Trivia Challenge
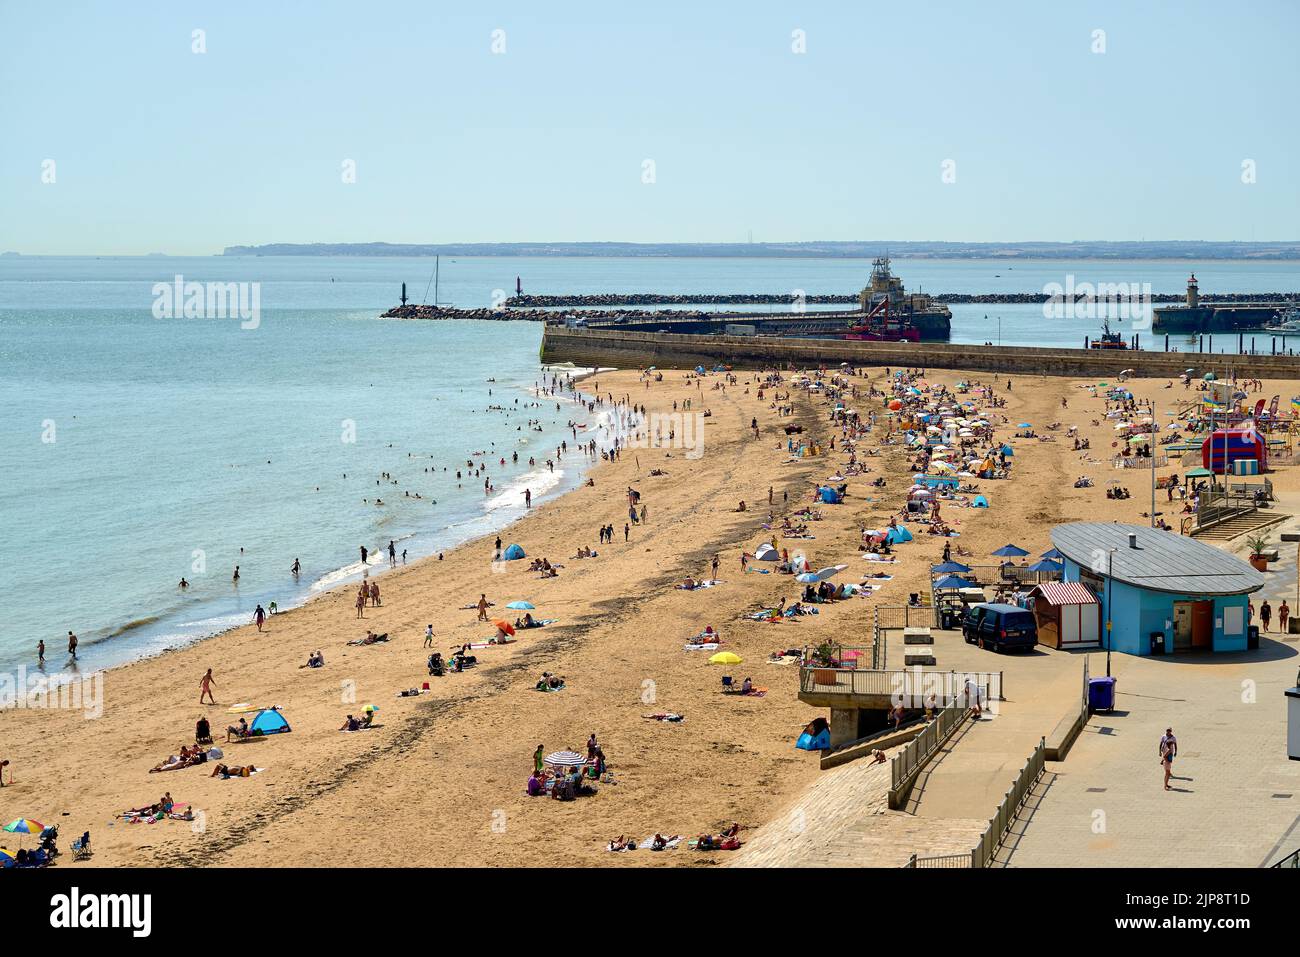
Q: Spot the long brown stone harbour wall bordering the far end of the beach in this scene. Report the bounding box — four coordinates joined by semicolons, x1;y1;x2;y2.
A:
542;326;1300;378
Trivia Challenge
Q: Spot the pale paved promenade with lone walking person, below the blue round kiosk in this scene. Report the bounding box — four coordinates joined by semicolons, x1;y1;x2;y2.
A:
1004;636;1300;867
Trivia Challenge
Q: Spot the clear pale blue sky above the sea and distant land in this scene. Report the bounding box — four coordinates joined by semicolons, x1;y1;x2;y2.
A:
0;0;1300;255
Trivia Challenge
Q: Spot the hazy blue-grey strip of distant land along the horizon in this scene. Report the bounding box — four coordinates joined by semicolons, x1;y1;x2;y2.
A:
221;239;1300;261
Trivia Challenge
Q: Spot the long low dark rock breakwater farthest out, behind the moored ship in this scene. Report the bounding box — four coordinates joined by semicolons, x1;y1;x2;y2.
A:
504;293;1294;309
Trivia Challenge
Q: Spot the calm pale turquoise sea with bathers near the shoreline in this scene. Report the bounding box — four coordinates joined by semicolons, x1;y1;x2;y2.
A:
0;256;1300;672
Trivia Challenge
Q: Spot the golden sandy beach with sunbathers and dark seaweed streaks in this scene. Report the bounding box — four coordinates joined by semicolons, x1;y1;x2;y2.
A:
0;369;1297;867
